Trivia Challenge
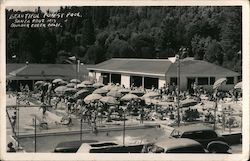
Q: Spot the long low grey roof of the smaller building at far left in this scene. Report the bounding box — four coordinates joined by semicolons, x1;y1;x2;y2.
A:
6;64;88;80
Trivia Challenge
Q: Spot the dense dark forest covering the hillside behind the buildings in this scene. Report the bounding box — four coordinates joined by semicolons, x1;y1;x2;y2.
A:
6;6;242;73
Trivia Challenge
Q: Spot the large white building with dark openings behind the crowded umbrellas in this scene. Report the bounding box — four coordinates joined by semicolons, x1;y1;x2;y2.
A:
87;58;240;90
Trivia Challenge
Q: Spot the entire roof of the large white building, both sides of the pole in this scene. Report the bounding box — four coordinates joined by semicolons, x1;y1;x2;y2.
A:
88;58;239;77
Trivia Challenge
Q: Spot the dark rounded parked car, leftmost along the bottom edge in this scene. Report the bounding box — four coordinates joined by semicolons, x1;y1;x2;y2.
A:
54;140;97;153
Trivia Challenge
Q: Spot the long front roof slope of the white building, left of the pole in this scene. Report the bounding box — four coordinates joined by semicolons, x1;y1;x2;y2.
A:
88;58;171;76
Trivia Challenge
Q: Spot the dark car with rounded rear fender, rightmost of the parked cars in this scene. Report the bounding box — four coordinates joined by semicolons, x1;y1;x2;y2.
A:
170;124;230;153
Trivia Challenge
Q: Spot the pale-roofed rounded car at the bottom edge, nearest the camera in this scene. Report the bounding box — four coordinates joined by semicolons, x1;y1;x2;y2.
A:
142;138;207;153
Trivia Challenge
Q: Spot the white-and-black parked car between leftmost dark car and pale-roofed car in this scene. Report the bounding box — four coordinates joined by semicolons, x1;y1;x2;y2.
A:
77;142;144;153
